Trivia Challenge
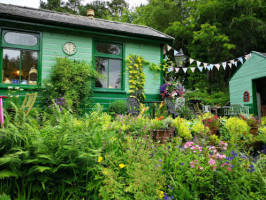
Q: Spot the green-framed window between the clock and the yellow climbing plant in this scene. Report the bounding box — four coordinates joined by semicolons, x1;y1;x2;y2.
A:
95;42;123;90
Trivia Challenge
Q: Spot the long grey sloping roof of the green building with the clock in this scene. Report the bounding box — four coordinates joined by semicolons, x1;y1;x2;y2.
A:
0;3;174;41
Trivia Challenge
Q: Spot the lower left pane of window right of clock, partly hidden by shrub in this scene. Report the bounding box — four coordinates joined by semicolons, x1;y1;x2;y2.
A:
95;57;108;88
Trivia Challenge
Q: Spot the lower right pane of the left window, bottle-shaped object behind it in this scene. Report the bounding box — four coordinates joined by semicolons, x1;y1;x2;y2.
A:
21;51;38;85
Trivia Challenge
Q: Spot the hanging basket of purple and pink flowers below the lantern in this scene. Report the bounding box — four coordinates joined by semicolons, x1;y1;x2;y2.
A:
160;81;184;99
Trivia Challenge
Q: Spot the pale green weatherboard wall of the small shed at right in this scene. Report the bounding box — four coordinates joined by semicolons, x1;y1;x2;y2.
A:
229;52;266;115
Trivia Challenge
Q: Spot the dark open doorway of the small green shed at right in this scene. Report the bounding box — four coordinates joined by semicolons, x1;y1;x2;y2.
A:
254;77;266;118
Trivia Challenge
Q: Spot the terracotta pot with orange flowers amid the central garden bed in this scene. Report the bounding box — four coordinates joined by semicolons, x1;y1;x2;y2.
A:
150;116;174;142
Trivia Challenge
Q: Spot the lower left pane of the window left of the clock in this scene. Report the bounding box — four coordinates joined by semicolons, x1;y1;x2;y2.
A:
2;49;20;84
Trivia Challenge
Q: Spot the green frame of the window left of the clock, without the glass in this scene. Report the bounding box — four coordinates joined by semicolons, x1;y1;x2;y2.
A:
0;27;42;89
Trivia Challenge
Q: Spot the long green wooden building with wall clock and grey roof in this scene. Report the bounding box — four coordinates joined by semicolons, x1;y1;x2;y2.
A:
0;4;174;111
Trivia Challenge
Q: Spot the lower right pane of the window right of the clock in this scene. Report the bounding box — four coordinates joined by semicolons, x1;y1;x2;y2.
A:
109;59;121;89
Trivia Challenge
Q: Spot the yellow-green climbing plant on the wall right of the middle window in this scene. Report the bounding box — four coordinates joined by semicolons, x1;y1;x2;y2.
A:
126;55;149;101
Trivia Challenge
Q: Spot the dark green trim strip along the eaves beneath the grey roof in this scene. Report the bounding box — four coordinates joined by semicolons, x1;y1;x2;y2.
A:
0;19;174;45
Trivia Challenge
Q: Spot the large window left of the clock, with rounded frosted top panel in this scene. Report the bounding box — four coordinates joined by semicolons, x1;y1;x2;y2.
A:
1;30;39;85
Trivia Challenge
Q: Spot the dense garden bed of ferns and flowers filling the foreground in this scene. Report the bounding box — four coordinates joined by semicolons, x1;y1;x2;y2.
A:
0;106;266;200
